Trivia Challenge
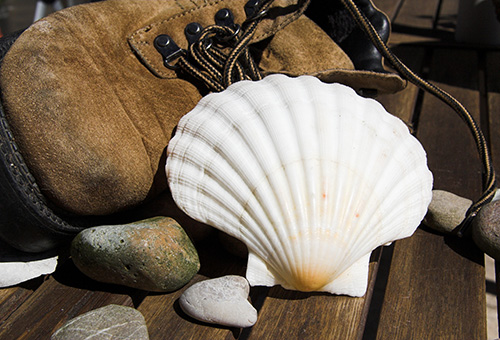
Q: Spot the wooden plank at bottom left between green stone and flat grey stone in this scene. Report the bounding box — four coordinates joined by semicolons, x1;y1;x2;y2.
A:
0;262;141;340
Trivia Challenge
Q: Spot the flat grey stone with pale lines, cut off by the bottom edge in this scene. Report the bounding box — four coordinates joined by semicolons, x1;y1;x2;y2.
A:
50;305;149;340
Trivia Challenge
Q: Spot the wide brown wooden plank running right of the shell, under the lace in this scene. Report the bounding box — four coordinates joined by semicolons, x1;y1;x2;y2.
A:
377;50;486;339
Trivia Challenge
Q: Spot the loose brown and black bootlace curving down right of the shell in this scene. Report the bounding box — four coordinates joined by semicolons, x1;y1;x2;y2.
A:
341;0;496;236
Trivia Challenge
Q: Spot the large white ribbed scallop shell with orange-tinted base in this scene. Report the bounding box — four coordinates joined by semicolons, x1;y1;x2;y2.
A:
166;75;432;296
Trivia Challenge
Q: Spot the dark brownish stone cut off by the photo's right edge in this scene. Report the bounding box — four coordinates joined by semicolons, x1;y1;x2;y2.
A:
471;201;500;261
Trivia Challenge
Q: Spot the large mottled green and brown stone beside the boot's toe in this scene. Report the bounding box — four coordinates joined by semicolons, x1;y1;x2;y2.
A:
71;217;200;292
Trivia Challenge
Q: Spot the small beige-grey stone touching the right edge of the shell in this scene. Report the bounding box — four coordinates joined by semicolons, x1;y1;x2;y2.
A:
424;190;472;234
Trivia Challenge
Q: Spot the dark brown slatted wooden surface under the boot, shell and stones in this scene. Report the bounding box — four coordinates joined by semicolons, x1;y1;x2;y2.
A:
0;0;500;340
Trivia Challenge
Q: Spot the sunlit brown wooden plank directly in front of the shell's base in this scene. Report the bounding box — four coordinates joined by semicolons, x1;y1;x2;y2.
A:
249;250;380;340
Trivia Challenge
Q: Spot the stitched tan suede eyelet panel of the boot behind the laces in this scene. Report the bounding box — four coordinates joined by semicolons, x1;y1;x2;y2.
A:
128;0;309;78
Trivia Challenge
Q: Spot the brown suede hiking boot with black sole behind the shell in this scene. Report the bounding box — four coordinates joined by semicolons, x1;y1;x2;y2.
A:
0;0;405;252
